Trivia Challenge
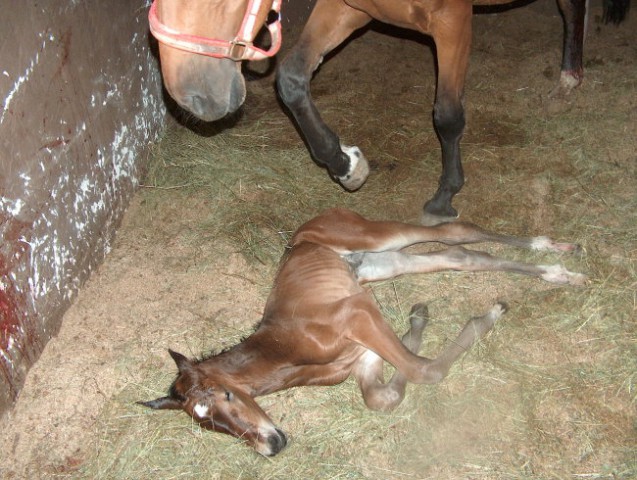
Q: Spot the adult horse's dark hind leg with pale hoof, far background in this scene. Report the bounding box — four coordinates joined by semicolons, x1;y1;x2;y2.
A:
549;0;588;97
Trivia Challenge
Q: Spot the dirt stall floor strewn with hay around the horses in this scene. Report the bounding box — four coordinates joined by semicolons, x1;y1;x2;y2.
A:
0;0;637;479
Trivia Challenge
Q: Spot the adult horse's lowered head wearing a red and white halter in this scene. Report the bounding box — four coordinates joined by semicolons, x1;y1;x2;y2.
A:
149;0;281;121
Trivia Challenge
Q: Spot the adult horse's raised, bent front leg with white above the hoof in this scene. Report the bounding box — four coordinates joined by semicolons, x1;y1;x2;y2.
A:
276;0;371;191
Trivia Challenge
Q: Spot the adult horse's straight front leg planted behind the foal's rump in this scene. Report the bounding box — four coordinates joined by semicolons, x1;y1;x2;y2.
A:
422;0;471;225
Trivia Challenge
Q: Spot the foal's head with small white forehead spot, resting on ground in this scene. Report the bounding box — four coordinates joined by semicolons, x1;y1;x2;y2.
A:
139;350;287;457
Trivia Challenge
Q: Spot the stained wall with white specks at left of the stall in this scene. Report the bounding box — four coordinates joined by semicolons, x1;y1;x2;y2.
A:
0;0;165;413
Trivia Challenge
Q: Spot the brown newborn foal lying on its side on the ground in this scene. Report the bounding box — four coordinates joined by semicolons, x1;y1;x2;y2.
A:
142;209;586;456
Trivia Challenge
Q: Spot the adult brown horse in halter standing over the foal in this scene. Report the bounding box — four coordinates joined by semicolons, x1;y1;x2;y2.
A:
149;0;630;225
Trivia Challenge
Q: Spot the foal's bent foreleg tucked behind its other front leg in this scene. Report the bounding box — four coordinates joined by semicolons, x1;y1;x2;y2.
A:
354;303;429;411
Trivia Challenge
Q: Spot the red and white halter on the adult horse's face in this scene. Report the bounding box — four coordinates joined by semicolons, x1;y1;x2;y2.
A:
148;0;282;62
